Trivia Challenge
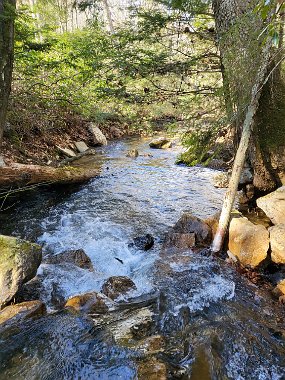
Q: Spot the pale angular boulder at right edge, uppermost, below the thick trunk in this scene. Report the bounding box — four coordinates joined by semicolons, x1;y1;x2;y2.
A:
256;186;285;224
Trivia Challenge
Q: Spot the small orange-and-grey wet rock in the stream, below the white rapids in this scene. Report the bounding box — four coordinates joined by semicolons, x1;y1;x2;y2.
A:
65;292;110;314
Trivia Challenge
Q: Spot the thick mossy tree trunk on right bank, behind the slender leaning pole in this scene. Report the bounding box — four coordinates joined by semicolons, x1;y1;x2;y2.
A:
213;0;285;194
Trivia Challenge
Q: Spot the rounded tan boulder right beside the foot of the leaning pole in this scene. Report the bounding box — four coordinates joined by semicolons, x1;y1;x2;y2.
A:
226;217;269;268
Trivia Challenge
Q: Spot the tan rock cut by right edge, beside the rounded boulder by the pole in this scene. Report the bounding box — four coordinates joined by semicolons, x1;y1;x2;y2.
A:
269;224;285;264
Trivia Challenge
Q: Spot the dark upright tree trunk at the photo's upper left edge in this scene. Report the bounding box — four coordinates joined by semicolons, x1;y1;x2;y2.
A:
0;0;16;154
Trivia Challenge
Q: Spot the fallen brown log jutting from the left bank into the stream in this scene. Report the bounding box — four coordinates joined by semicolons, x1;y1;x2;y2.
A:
0;163;100;189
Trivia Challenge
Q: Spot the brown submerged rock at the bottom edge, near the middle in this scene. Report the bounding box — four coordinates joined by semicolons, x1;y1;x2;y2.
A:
138;358;167;380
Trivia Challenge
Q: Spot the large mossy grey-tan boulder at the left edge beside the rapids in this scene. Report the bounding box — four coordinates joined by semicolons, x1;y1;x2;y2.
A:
0;235;42;308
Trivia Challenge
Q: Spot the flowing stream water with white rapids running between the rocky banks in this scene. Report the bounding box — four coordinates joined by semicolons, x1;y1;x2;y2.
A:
0;139;285;380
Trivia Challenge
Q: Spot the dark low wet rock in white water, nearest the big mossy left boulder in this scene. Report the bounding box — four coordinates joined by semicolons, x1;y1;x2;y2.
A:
43;249;94;271
